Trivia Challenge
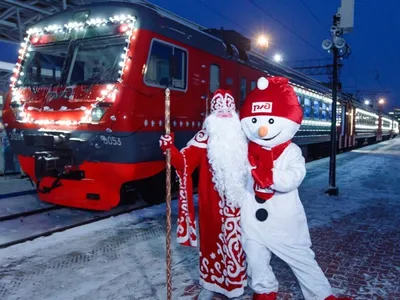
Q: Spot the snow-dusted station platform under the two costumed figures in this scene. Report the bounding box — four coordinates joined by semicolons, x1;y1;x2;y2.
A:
0;139;400;300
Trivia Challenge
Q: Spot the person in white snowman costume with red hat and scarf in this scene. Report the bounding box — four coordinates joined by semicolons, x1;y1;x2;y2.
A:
240;77;350;300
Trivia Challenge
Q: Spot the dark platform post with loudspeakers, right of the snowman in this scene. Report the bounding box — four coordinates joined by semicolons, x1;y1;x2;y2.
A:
322;0;354;196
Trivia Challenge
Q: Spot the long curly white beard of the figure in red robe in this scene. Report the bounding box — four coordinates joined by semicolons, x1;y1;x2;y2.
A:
204;112;250;207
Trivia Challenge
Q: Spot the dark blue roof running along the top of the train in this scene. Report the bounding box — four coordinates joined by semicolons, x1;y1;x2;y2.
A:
27;0;394;117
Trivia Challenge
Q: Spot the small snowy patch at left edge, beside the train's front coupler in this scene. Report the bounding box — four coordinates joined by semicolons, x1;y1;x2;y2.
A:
0;176;36;199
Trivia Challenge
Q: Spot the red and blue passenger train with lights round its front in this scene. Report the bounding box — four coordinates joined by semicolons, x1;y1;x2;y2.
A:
3;1;398;210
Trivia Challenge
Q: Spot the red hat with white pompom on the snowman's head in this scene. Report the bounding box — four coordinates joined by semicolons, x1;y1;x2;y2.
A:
240;77;303;125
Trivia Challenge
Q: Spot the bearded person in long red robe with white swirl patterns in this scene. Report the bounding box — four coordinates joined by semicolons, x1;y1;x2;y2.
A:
160;90;250;299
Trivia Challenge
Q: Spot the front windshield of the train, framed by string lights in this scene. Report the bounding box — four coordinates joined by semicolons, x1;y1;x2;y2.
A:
16;36;126;87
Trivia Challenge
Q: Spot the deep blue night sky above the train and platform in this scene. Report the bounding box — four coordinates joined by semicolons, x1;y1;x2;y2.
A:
0;0;400;110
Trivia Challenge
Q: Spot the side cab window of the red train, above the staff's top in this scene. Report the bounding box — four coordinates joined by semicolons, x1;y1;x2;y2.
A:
144;40;187;90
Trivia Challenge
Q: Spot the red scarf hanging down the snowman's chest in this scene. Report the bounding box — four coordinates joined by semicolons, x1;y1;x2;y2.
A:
248;140;292;200
